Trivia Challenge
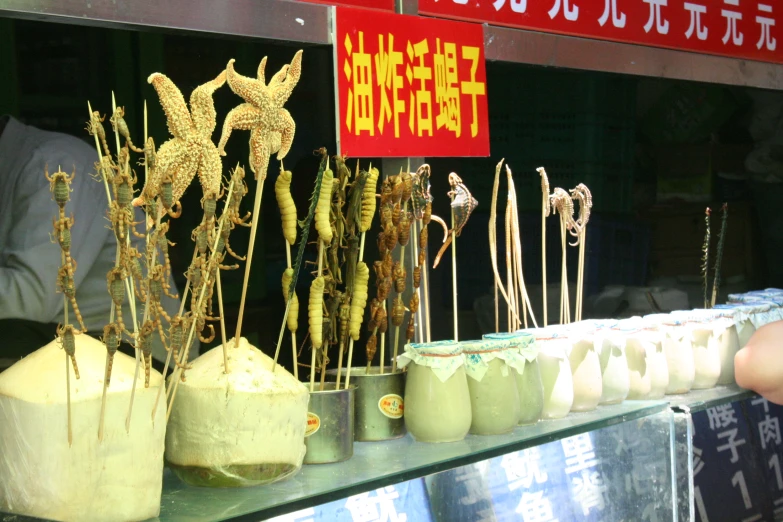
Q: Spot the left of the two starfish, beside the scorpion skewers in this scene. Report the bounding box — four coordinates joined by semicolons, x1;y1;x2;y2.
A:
133;71;226;207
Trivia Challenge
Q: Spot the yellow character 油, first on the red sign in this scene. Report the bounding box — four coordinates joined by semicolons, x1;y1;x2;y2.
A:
343;31;375;136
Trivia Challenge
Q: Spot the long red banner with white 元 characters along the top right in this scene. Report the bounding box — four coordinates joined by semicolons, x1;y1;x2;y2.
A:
419;0;783;63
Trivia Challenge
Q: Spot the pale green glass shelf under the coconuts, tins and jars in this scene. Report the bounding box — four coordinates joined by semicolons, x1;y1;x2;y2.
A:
159;401;669;522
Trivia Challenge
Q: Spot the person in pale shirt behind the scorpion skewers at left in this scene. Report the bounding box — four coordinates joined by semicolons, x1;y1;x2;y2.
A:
0;116;188;370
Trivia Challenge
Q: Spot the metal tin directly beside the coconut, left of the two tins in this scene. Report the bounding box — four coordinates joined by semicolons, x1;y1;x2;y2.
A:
304;382;356;464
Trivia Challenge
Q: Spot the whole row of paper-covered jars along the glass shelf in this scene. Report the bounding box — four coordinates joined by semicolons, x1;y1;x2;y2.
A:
399;289;783;442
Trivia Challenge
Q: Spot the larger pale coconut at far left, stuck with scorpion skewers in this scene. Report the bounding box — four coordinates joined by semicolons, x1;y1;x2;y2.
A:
0;335;166;522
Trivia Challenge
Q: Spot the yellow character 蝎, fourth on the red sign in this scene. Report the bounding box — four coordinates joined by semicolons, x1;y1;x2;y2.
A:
434;38;462;138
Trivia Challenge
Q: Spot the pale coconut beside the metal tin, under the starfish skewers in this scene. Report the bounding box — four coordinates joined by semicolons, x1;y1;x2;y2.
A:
166;338;309;487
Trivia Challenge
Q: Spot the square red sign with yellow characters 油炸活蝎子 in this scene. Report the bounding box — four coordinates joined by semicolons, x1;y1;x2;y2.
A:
334;7;489;157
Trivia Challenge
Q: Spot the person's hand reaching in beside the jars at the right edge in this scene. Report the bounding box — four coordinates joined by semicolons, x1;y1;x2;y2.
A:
734;321;783;405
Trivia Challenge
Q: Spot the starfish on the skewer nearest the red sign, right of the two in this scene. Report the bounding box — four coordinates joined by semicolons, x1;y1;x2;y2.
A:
218;51;302;179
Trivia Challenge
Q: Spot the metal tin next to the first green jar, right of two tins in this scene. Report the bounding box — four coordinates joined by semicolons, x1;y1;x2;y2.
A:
327;366;407;442
